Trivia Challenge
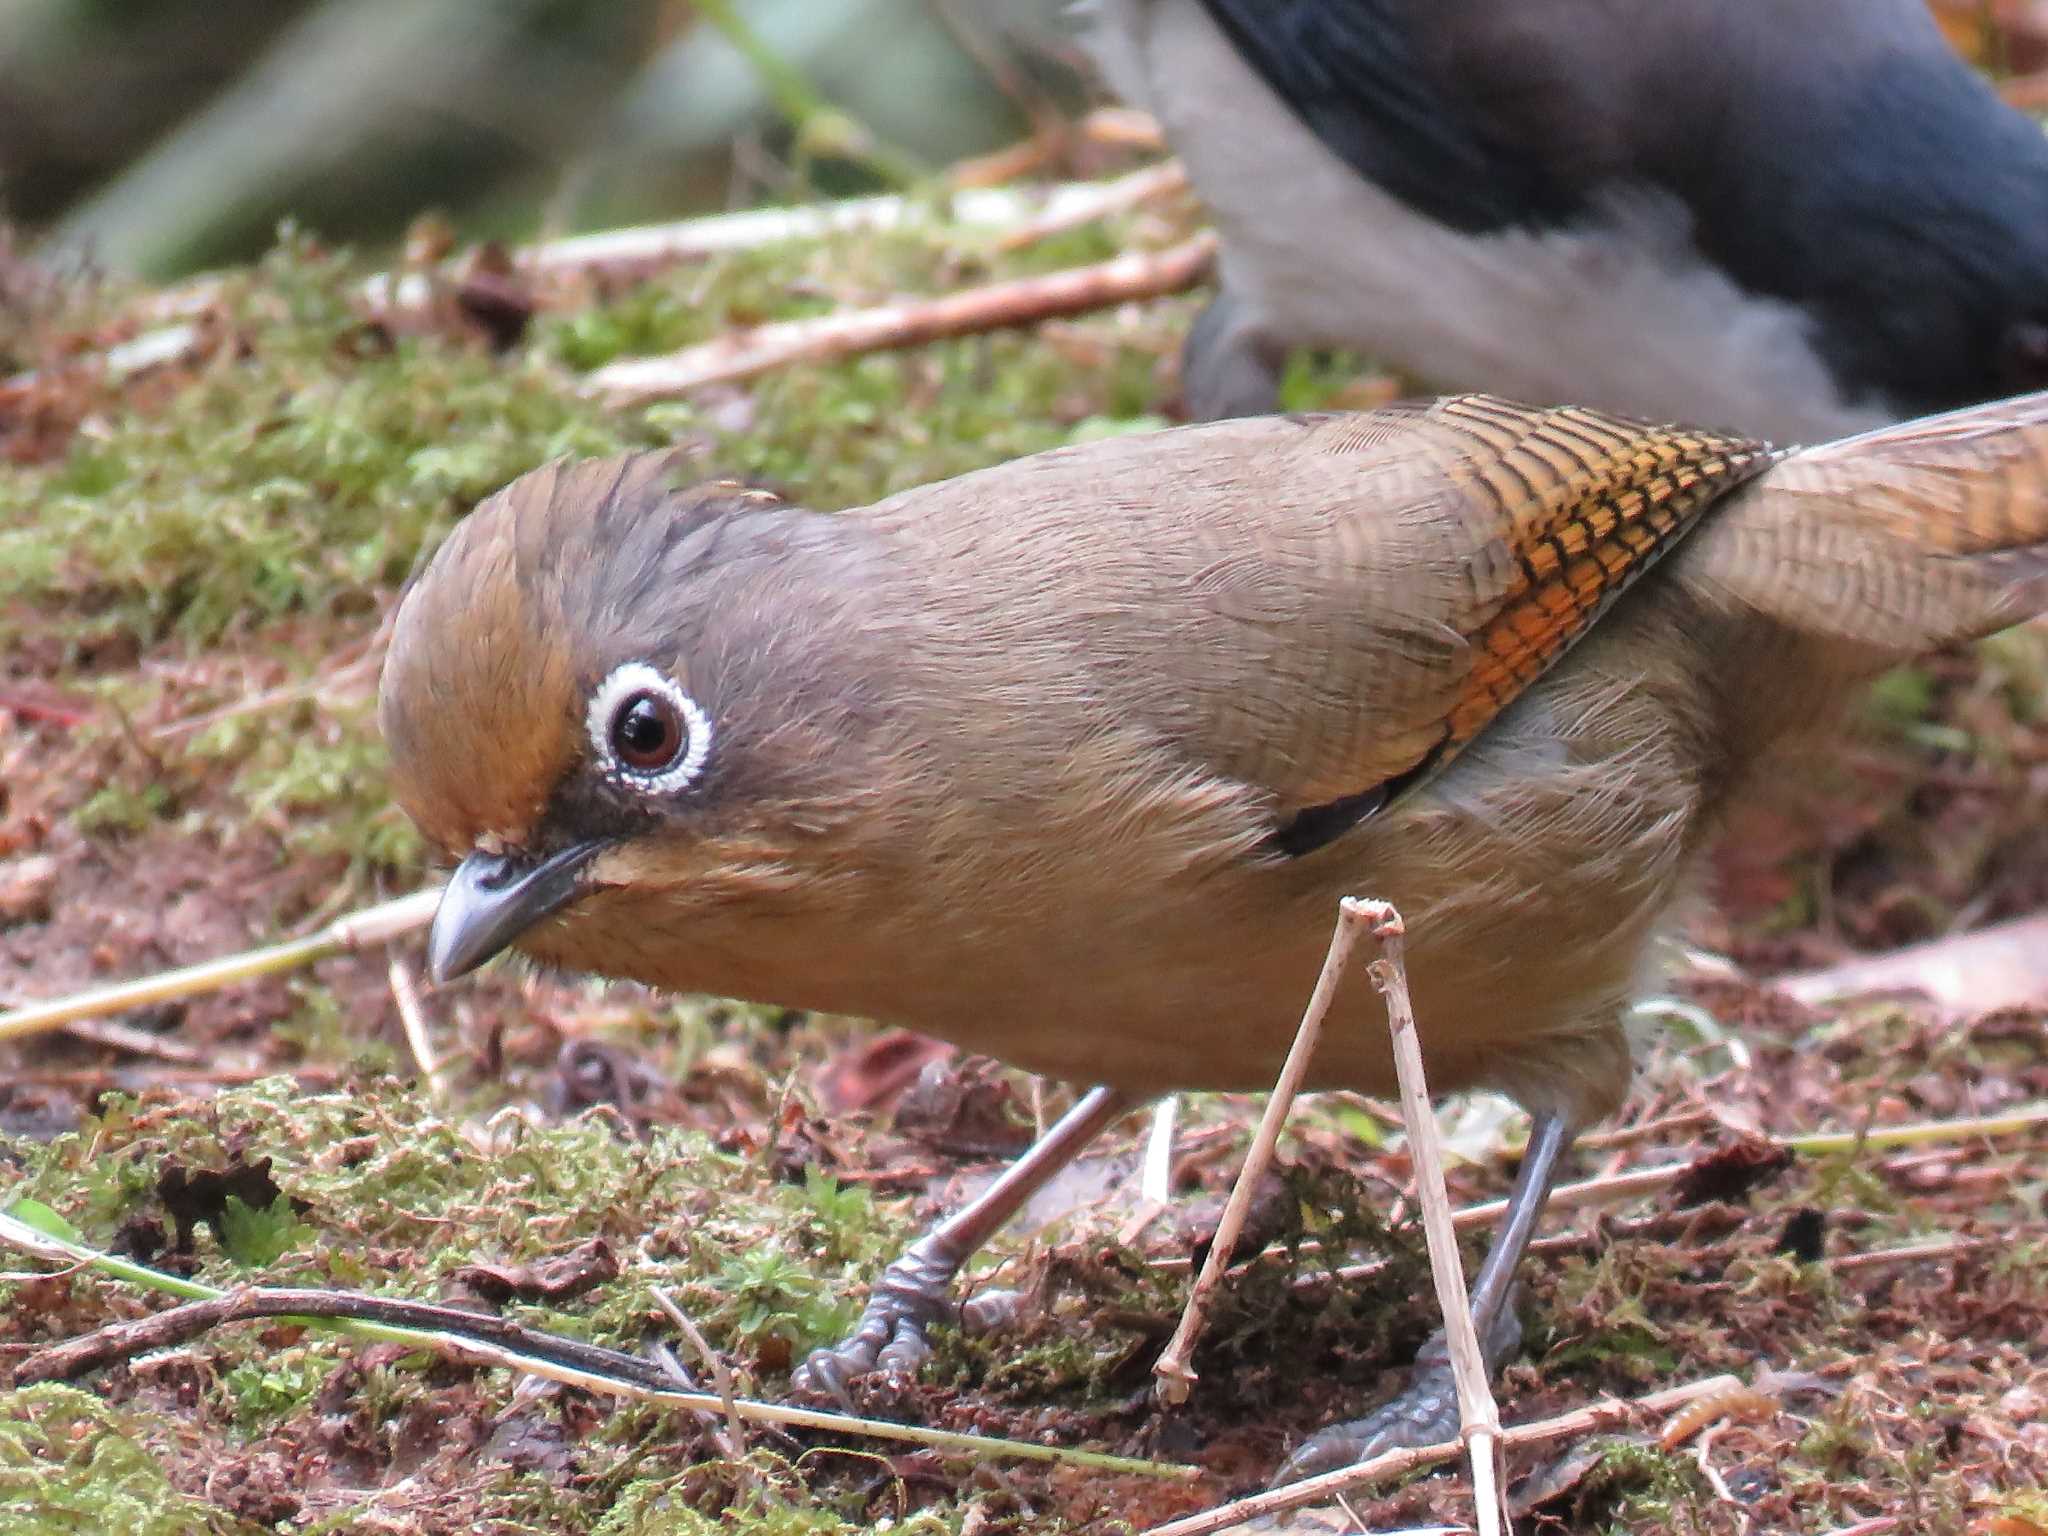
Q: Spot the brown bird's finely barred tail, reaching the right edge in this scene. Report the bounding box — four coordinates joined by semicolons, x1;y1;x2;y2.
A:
1675;391;2048;659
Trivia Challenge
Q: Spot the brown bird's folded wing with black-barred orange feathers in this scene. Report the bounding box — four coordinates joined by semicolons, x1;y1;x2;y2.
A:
1130;397;1769;846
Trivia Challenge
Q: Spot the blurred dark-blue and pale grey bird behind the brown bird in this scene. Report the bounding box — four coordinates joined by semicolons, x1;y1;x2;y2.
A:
1083;0;2048;442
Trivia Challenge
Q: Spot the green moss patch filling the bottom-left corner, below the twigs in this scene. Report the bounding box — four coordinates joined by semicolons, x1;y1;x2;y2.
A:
0;1384;250;1536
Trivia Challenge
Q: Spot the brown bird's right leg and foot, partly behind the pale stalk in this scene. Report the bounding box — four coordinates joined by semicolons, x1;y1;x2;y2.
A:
1274;1114;1571;1485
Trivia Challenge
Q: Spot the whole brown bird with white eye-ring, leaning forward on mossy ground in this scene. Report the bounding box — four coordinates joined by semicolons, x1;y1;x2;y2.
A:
381;393;2048;1475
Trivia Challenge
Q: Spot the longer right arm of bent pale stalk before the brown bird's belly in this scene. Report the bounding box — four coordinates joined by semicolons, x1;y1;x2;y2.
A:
1339;897;1505;1536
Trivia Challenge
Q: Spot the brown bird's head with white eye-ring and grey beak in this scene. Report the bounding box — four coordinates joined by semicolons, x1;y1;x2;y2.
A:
379;453;892;983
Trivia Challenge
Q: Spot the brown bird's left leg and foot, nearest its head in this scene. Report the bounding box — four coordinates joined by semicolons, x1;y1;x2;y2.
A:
797;1087;1137;1399
